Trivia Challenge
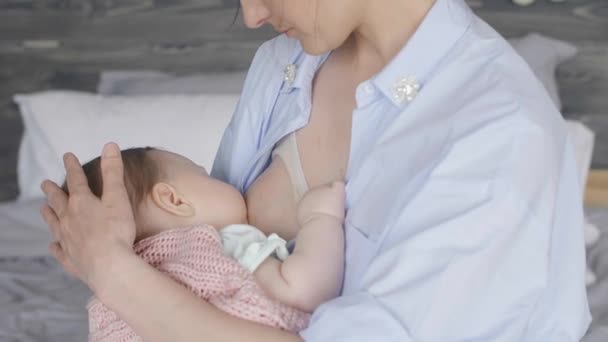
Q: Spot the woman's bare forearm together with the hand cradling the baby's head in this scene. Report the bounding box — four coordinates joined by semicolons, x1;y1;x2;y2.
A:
42;144;299;341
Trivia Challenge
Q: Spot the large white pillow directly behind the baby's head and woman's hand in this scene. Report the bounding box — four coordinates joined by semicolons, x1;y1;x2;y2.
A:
15;91;238;201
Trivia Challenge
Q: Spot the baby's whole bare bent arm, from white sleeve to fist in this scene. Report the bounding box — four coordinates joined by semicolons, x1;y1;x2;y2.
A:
254;182;344;312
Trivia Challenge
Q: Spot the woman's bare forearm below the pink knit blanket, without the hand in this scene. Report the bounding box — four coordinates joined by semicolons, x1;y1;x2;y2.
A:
94;248;301;342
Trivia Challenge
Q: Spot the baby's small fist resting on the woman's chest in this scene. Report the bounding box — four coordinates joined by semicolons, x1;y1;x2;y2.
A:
298;182;345;225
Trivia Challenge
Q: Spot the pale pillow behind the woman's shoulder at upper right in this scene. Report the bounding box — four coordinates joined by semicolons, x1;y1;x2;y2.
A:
509;33;578;110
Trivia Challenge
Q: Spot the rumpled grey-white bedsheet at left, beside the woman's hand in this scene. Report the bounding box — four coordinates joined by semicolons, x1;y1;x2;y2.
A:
0;199;91;342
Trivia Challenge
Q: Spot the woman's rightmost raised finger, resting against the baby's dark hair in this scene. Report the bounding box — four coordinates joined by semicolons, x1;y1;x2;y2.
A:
101;143;129;204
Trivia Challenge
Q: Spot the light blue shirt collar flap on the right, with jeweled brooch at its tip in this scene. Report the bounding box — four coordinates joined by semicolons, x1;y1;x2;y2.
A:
371;0;473;107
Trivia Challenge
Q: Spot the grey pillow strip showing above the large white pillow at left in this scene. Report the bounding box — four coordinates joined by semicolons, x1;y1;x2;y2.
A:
97;71;247;95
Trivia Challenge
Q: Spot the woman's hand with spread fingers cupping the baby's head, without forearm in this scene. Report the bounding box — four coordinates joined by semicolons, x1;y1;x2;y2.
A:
41;143;135;292
